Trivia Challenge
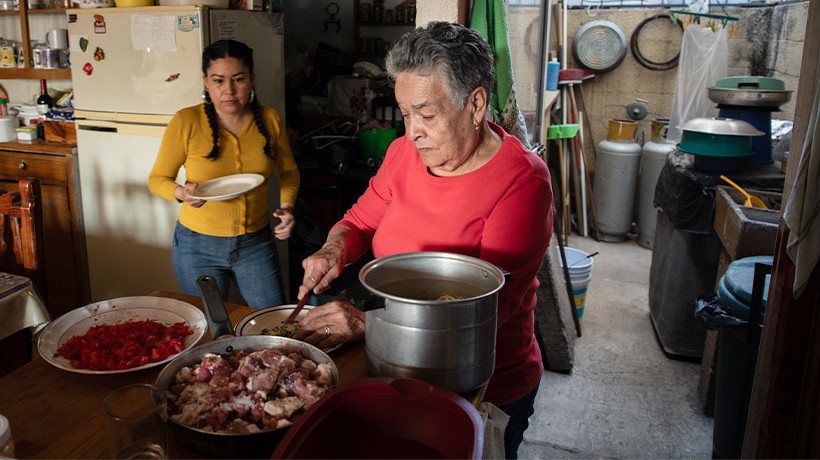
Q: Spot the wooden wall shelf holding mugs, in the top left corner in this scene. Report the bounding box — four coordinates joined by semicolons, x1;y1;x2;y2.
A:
0;5;71;80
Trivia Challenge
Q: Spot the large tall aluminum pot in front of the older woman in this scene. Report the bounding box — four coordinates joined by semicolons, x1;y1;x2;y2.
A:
348;252;504;393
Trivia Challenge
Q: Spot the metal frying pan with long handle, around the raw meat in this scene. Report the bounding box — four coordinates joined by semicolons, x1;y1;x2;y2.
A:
156;276;339;458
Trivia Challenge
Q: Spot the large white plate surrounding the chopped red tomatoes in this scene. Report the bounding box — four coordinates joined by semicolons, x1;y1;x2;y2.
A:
37;296;208;374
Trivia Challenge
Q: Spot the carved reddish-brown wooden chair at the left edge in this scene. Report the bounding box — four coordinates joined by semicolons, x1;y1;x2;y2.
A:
0;179;47;375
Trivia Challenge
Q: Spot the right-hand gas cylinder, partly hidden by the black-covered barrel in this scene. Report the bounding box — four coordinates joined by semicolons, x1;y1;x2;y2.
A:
638;118;675;249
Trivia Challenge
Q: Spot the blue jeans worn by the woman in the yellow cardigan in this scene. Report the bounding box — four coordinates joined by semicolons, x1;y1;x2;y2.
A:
172;222;285;308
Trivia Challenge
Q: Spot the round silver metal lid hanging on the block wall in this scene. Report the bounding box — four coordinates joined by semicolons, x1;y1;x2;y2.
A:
572;19;627;73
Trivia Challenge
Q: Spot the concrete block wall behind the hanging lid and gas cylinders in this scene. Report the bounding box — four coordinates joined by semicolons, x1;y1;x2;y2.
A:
508;1;808;171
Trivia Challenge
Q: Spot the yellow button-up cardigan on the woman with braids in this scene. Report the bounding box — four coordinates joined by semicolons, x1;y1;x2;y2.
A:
148;104;300;236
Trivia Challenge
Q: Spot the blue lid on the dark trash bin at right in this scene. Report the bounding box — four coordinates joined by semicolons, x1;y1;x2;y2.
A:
717;256;774;320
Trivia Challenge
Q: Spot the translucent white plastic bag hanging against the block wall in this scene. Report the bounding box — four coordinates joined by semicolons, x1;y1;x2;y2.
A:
666;25;729;143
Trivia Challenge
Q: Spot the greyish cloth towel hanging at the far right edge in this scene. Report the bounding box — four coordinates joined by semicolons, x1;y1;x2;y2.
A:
783;50;820;299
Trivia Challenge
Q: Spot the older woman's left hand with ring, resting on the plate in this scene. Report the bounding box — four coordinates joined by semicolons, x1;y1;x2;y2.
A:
294;300;365;349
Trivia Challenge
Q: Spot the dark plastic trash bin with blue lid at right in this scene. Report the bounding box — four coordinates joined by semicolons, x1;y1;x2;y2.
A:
696;256;772;458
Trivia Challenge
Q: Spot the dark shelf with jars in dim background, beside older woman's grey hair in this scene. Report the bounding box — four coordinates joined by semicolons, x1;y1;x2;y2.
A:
353;0;416;58
